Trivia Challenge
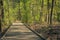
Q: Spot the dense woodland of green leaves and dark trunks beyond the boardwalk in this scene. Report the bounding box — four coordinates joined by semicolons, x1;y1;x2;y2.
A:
0;0;60;37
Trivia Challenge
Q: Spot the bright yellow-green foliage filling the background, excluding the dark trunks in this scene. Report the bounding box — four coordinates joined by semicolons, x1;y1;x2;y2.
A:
4;0;60;31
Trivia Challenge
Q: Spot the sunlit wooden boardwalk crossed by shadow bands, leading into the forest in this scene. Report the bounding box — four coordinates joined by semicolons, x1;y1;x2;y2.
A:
1;23;41;40
